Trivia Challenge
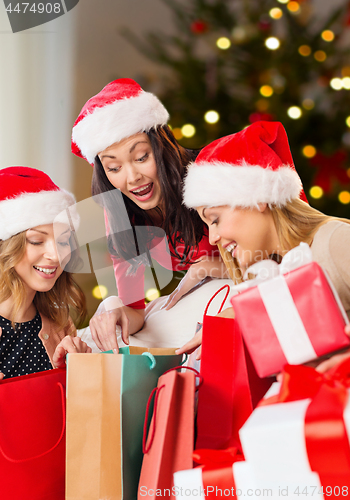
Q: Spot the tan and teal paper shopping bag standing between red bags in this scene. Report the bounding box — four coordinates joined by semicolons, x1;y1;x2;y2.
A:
66;347;181;500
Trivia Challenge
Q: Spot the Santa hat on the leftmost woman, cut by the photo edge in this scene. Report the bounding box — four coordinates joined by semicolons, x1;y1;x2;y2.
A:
0;167;75;240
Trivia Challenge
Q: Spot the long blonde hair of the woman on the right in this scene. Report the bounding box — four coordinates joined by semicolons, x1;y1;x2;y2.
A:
218;199;350;283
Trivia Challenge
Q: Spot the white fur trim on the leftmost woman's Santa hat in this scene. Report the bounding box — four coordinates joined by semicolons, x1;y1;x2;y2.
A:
0;189;75;240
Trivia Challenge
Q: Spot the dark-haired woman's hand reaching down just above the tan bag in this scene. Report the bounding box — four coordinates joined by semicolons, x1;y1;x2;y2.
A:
89;307;129;353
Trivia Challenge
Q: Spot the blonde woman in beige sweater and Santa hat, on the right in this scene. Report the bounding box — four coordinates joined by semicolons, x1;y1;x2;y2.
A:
178;122;350;369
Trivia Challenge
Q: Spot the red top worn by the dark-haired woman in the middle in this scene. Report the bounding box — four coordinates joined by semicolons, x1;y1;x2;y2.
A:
111;229;220;309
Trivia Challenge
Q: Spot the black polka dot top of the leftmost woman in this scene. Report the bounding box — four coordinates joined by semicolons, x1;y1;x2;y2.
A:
0;313;52;378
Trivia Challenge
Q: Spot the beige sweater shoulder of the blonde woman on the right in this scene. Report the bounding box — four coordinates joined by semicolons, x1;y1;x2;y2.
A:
311;221;350;319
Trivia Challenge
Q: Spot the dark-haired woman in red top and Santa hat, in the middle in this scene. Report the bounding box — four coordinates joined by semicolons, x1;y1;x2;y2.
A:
72;79;226;349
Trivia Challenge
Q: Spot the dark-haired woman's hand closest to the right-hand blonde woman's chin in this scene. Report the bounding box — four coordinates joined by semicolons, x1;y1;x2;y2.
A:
162;256;228;310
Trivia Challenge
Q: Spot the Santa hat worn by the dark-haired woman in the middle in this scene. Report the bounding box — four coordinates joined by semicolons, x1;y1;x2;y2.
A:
72;78;169;165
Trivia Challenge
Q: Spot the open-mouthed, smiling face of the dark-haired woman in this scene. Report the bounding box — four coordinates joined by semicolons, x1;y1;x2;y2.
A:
98;133;162;210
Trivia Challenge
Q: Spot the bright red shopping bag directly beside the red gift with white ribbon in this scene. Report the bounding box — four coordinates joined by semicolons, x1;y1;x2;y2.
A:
196;285;273;449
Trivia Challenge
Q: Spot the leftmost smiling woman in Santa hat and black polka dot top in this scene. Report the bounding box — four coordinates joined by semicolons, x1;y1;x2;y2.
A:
0;167;91;378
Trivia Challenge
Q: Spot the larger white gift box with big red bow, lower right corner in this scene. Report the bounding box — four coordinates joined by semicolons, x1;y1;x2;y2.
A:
238;358;350;490
